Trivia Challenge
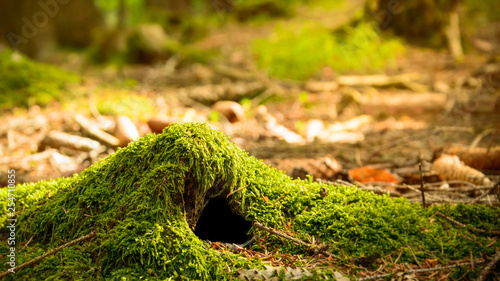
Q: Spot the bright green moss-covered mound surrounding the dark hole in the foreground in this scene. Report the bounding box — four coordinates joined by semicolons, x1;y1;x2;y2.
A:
0;123;500;280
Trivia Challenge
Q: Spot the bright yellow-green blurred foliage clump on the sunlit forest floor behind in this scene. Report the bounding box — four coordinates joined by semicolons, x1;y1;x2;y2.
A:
253;23;403;80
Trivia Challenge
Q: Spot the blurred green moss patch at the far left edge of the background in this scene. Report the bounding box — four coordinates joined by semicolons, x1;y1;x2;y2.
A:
0;49;80;109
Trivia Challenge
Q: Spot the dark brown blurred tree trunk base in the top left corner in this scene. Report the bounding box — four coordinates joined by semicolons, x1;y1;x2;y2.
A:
0;0;103;58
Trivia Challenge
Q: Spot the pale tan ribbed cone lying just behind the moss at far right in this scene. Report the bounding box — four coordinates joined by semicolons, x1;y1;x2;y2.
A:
432;154;491;185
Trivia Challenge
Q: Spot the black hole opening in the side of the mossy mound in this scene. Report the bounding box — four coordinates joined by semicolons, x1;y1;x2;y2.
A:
194;198;252;244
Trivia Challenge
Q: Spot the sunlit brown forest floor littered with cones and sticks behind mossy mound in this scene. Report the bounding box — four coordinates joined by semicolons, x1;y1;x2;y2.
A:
0;8;500;280
